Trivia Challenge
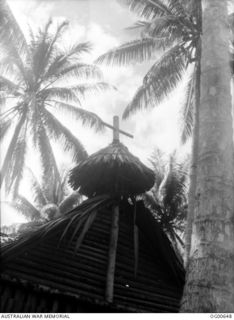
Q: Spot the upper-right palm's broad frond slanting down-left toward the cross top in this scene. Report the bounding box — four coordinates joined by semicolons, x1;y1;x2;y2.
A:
123;44;187;119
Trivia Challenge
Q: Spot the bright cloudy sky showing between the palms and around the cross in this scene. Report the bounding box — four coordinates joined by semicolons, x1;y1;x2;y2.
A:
2;0;189;224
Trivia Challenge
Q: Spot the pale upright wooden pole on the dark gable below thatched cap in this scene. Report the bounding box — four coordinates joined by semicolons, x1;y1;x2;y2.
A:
105;206;119;302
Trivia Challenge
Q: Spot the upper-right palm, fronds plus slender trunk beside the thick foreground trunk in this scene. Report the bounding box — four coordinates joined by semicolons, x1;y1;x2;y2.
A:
97;0;201;265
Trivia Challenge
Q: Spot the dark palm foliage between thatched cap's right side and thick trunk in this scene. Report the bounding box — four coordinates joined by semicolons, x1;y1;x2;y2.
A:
144;150;188;256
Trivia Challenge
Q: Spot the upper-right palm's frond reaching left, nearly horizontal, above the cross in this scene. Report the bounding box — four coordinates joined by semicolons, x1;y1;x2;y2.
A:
95;38;160;65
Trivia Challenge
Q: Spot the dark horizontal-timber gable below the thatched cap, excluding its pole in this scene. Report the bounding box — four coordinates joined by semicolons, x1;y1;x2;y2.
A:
1;200;184;312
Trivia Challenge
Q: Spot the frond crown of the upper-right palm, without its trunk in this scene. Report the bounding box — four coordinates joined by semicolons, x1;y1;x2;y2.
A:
97;0;201;139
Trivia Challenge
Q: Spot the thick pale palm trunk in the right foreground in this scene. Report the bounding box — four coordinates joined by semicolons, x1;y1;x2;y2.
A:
181;0;234;312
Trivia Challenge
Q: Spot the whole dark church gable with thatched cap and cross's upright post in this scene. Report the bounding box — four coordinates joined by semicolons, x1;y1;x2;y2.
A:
2;117;184;312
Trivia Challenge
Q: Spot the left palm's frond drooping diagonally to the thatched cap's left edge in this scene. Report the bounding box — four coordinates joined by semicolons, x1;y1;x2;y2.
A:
44;111;87;162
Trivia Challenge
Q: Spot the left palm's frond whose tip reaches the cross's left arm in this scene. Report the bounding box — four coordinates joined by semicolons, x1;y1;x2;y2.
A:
49;101;104;130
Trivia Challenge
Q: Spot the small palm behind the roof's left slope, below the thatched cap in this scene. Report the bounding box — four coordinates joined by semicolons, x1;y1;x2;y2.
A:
5;168;82;232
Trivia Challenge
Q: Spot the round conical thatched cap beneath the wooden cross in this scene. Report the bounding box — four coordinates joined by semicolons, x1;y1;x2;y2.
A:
69;141;154;197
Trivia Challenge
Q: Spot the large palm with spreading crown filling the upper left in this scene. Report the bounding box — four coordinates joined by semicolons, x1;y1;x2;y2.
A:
0;0;108;198
